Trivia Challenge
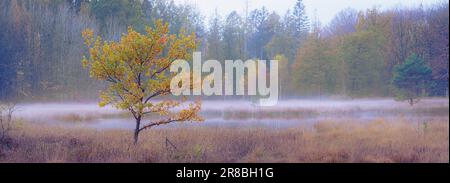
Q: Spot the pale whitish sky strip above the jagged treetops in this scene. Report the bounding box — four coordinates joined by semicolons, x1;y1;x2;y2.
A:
174;0;443;25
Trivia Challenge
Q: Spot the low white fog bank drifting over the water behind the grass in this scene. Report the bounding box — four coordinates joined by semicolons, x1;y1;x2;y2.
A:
15;99;449;130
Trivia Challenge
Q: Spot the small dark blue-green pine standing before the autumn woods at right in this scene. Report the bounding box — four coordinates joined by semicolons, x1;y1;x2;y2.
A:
392;54;432;105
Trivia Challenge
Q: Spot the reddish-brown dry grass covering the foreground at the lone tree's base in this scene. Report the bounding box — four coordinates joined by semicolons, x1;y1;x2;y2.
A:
0;119;449;163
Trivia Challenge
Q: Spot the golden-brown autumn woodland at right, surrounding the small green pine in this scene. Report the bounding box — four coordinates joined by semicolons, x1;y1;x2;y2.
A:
290;3;449;97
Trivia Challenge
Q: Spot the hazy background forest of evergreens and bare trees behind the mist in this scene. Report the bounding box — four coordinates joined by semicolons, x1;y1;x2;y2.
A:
0;0;449;100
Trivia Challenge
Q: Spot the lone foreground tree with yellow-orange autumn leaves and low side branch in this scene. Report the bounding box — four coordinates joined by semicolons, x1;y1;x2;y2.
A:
82;21;203;144
